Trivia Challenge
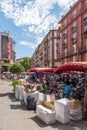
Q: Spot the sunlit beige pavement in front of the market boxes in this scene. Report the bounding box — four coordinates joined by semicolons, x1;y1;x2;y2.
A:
0;81;87;130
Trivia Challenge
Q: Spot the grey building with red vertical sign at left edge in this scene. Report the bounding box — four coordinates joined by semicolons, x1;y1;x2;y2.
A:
0;32;15;71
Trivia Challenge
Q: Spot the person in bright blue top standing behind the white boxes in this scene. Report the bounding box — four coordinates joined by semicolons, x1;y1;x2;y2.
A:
64;81;72;99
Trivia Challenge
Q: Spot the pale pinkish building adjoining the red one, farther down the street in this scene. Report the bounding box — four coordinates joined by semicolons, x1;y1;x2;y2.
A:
32;29;60;67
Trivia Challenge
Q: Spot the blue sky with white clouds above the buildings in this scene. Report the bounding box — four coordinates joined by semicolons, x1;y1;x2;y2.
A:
0;0;77;59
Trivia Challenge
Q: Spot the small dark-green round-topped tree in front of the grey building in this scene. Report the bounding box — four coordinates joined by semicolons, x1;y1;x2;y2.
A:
9;63;25;74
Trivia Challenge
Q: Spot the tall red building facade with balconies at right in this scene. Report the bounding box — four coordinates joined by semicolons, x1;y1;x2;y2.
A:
59;0;87;64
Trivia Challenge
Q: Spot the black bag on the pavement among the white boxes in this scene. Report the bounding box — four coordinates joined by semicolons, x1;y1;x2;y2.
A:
26;96;36;110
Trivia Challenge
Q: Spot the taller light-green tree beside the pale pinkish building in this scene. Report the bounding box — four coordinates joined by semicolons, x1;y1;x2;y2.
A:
20;57;32;71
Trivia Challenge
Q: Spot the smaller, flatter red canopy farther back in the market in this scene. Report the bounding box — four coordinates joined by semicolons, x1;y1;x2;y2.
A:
27;68;55;73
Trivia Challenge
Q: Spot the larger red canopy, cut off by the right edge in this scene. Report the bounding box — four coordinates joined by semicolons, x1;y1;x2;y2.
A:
54;62;87;73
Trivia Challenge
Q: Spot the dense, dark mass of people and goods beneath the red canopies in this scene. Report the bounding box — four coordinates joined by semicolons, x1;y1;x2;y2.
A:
28;72;85;100
